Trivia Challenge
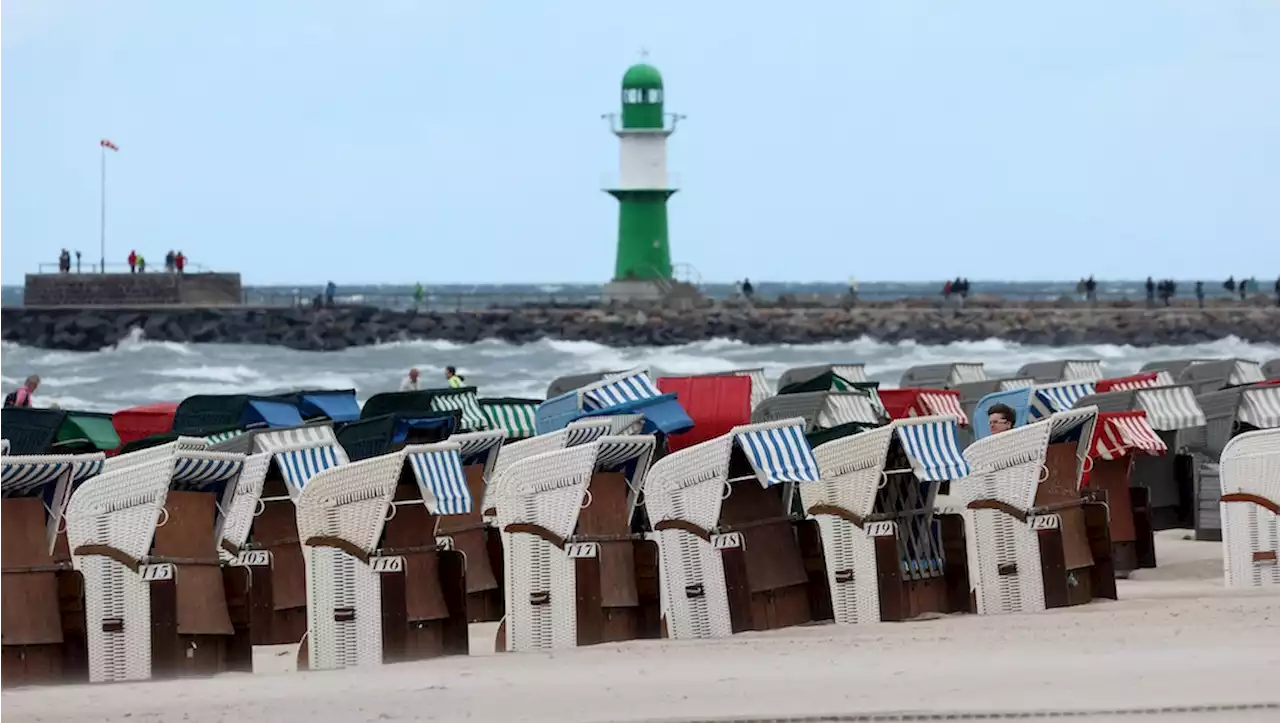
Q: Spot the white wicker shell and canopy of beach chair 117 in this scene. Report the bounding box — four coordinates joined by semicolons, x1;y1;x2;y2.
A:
498;435;655;650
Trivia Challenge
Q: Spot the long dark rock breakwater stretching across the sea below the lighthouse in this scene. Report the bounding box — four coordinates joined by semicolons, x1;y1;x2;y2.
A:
0;299;1280;351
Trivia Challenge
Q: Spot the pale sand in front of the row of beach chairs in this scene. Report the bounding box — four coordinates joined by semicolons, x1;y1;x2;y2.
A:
0;531;1280;723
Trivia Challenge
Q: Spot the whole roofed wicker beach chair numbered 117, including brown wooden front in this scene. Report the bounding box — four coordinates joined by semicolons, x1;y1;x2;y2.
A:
486;435;660;651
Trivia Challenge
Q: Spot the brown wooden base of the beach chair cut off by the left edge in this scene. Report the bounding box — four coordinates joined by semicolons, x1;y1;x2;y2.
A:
0;498;88;687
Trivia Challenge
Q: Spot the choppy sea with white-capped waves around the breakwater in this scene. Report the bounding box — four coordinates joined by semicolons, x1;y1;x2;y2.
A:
0;282;1280;412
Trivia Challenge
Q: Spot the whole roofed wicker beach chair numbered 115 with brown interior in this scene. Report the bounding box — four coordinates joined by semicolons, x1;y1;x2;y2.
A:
67;438;244;682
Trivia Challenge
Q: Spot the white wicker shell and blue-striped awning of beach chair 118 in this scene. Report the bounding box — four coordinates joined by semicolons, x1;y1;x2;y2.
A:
644;418;819;639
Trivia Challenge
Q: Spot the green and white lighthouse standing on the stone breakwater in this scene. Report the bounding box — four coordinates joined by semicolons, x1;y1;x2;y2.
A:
604;63;681;298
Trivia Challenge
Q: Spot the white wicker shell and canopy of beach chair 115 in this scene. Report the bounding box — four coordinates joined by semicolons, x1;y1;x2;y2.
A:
67;440;244;682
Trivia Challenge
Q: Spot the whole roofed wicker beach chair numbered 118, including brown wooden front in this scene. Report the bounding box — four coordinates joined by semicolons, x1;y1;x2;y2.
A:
644;418;831;639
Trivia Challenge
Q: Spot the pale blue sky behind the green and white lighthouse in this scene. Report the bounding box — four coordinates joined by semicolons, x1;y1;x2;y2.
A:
0;0;1280;284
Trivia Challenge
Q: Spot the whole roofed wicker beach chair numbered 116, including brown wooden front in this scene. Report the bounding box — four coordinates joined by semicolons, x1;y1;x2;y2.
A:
294;441;472;671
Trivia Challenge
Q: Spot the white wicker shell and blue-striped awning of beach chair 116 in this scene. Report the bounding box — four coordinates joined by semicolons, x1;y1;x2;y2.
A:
294;441;472;671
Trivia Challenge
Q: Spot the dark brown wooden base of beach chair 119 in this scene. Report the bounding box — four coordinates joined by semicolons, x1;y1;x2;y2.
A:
876;514;977;622
